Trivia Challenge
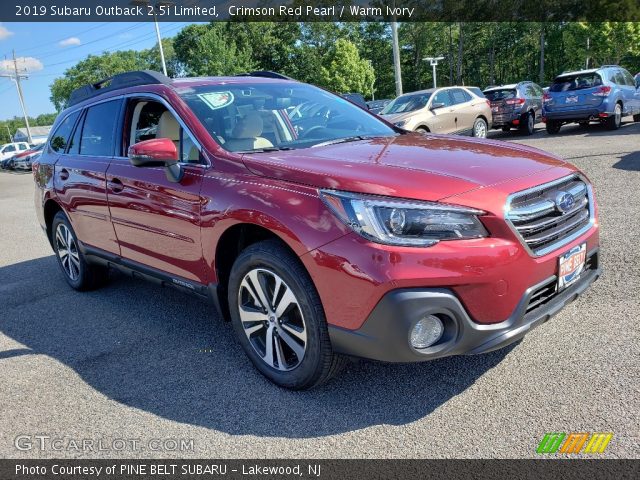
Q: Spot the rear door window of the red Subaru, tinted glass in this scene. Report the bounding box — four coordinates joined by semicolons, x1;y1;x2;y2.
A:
80;100;121;157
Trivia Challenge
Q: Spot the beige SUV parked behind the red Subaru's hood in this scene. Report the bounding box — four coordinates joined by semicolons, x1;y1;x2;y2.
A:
380;87;492;138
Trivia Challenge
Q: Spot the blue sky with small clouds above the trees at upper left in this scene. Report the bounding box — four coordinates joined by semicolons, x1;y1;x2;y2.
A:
0;22;195;120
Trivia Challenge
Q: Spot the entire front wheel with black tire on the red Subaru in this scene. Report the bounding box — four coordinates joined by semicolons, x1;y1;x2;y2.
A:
228;240;345;390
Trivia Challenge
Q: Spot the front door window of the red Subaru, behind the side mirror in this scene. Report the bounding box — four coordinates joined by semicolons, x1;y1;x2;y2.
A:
129;100;201;163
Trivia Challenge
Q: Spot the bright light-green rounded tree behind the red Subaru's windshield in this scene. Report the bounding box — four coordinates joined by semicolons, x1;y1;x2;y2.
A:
319;38;375;96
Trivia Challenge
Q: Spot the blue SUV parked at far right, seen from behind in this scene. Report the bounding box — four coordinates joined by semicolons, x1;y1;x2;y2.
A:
543;65;640;134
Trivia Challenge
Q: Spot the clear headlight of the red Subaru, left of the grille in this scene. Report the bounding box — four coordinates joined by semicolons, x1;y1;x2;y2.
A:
320;190;489;247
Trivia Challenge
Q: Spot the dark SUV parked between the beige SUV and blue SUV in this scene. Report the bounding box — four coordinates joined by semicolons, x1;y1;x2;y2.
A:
483;81;543;135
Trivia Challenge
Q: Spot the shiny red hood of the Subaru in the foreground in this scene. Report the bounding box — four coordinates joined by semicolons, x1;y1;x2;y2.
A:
243;133;564;201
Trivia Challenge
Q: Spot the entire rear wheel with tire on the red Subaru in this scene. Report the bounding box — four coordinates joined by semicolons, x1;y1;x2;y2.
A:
51;211;109;291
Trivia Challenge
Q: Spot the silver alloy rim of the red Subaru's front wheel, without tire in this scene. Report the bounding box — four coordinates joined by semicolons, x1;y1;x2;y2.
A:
238;268;307;371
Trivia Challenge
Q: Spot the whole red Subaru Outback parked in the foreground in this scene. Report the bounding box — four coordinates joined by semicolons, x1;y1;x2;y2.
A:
33;72;600;389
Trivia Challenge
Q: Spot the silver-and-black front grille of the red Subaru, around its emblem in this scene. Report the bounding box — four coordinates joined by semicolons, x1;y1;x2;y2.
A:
506;176;593;256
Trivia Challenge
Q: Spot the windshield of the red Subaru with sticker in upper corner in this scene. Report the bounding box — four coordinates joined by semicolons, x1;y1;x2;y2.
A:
177;83;398;153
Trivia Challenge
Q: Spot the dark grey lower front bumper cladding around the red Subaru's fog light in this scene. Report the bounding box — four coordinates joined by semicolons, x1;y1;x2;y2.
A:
329;250;601;362
